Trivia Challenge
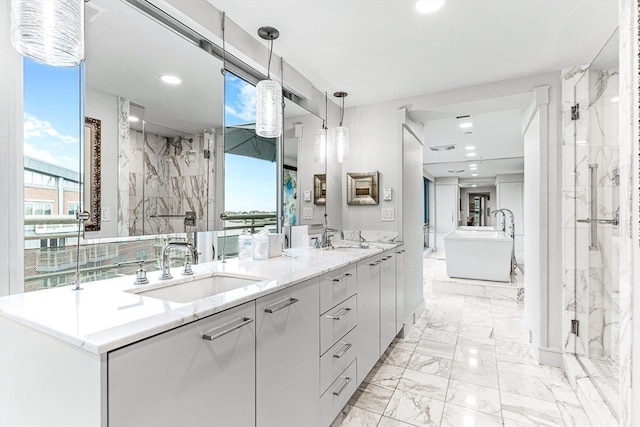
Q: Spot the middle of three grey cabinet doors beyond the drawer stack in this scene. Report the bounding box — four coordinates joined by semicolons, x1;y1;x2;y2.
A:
380;250;396;354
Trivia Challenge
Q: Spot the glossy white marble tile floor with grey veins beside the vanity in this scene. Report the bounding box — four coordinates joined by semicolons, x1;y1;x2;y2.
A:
333;258;591;427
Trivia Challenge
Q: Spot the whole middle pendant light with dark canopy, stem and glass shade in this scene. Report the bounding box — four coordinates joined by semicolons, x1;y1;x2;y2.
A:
256;27;282;138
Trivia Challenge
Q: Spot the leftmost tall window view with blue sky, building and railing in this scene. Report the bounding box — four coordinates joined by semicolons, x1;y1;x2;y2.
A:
23;58;82;291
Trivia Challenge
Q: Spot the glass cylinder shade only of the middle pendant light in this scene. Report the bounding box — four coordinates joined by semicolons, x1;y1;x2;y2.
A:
256;80;282;138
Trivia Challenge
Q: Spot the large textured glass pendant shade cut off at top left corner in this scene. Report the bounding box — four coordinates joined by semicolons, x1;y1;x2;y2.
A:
11;0;84;67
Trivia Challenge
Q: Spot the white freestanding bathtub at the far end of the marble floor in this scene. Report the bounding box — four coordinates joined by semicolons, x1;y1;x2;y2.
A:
444;230;513;282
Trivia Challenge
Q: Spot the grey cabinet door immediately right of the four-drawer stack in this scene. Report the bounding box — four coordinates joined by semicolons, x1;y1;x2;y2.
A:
357;255;381;384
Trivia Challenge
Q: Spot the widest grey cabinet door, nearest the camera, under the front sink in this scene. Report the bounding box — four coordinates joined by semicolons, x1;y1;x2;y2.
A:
108;302;256;427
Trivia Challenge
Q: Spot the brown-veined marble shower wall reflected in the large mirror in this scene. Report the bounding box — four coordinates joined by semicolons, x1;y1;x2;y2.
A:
118;100;216;236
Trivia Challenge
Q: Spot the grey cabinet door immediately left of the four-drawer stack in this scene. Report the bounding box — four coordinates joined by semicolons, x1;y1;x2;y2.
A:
256;279;320;427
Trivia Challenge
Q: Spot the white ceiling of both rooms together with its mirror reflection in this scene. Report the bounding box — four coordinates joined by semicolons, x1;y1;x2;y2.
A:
86;0;617;178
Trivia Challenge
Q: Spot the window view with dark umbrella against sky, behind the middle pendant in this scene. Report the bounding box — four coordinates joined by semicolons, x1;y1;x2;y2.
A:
224;72;277;244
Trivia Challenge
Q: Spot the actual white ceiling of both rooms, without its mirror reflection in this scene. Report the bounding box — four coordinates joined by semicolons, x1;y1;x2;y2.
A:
208;0;617;182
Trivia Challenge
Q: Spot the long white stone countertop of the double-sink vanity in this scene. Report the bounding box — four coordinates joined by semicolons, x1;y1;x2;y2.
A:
0;243;398;354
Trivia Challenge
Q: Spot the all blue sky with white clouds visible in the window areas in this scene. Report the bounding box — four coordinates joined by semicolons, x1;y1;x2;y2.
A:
24;62;276;212
